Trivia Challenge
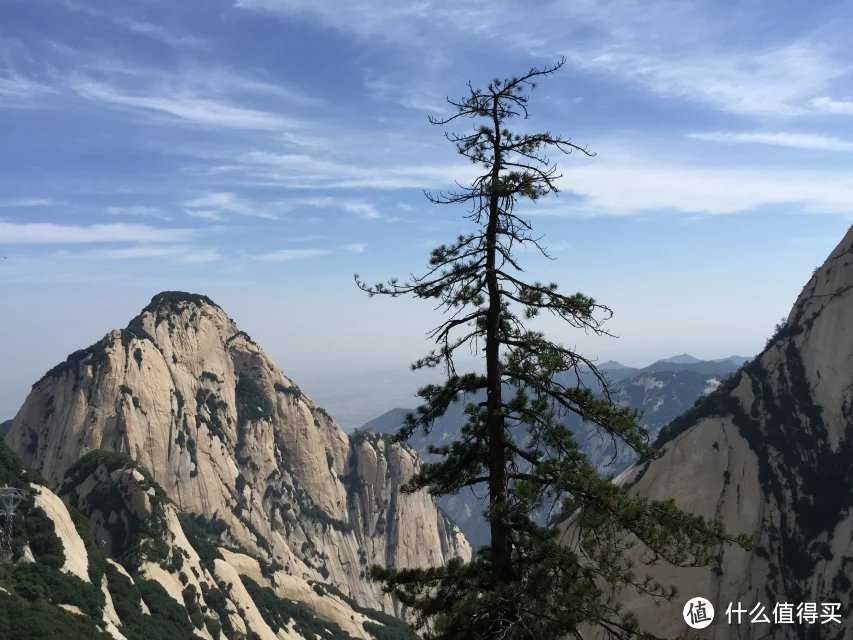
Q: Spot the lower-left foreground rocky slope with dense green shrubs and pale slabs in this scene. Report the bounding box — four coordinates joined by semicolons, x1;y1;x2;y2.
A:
0;443;416;640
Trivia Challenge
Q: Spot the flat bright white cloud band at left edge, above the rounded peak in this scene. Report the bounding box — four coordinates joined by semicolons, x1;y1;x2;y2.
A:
0;221;195;245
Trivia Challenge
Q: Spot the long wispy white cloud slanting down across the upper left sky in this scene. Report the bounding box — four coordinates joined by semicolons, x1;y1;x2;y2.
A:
0;38;316;135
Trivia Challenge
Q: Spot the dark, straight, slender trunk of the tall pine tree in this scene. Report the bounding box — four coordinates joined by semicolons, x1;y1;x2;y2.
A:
486;99;514;581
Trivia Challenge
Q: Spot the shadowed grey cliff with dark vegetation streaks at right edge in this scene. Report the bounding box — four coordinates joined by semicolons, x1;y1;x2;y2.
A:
588;229;853;640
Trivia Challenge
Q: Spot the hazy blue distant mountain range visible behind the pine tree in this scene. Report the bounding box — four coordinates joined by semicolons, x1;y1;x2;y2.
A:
363;354;751;547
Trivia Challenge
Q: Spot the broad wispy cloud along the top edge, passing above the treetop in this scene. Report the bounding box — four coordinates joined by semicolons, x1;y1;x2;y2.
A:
235;0;851;115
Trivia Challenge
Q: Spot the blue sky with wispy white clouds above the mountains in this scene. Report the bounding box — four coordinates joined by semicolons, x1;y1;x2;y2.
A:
0;0;853;428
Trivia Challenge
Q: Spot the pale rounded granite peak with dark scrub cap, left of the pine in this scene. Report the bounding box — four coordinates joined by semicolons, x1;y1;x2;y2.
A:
6;292;470;611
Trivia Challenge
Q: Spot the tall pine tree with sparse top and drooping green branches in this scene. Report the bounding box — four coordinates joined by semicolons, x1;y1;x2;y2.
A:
356;60;748;640
